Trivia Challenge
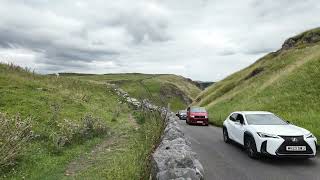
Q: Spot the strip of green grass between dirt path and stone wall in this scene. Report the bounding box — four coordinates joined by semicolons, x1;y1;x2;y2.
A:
71;112;164;180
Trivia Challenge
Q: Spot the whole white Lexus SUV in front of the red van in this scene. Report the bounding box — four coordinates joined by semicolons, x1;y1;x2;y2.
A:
223;111;317;158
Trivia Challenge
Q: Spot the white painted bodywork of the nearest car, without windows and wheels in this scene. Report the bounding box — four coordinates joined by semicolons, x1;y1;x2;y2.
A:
223;111;317;156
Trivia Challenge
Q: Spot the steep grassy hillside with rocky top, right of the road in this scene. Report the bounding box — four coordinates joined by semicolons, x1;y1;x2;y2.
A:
194;28;320;138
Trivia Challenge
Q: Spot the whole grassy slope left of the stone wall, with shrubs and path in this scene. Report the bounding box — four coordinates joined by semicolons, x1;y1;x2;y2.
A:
0;64;163;179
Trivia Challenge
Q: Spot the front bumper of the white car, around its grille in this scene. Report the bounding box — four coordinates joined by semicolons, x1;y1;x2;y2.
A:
256;136;316;157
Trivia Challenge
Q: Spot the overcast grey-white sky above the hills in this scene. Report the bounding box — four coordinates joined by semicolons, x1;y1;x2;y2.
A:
0;0;320;81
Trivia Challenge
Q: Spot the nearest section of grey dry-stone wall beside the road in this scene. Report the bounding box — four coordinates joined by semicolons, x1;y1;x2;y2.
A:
151;112;204;180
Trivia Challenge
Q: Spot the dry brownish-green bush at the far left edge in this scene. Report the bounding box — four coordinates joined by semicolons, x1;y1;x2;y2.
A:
0;113;32;169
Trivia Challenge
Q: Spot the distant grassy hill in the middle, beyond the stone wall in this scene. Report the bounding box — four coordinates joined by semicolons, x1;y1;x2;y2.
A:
64;73;201;111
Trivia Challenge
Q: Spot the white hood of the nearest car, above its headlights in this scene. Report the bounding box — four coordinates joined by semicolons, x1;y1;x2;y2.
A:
250;124;310;136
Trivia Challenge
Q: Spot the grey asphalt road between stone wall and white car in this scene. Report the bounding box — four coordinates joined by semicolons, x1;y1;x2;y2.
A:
178;120;320;180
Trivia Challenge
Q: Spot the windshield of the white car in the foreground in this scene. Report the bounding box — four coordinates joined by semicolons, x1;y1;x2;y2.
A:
246;114;288;125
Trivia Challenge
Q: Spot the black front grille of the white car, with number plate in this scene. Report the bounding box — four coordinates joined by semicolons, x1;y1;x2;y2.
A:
276;136;313;155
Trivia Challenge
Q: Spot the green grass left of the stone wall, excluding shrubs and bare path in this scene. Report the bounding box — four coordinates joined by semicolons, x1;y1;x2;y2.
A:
0;63;163;179
